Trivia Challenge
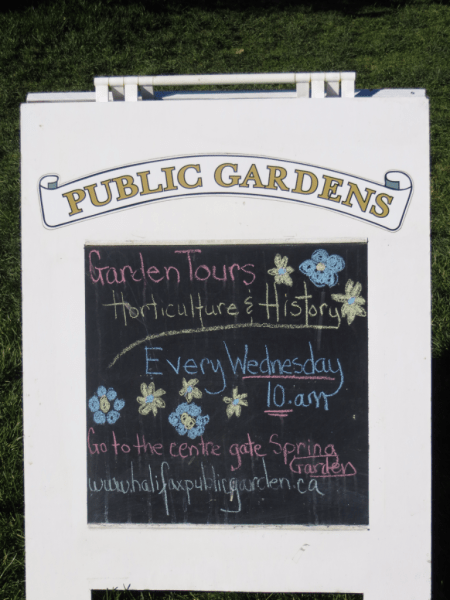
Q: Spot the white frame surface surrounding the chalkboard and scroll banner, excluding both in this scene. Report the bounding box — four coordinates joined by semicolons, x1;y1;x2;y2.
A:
22;77;431;600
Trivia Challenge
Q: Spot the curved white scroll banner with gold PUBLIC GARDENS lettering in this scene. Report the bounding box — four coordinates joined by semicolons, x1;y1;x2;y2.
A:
39;154;412;231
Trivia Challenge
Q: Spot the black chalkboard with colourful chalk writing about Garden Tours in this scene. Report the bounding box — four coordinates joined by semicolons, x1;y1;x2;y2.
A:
85;243;368;525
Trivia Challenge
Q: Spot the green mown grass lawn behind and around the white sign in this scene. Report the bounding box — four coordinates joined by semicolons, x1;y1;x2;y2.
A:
0;0;450;600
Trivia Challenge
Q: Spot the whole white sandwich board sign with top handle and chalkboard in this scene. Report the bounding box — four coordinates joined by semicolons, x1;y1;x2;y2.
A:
22;73;431;600
